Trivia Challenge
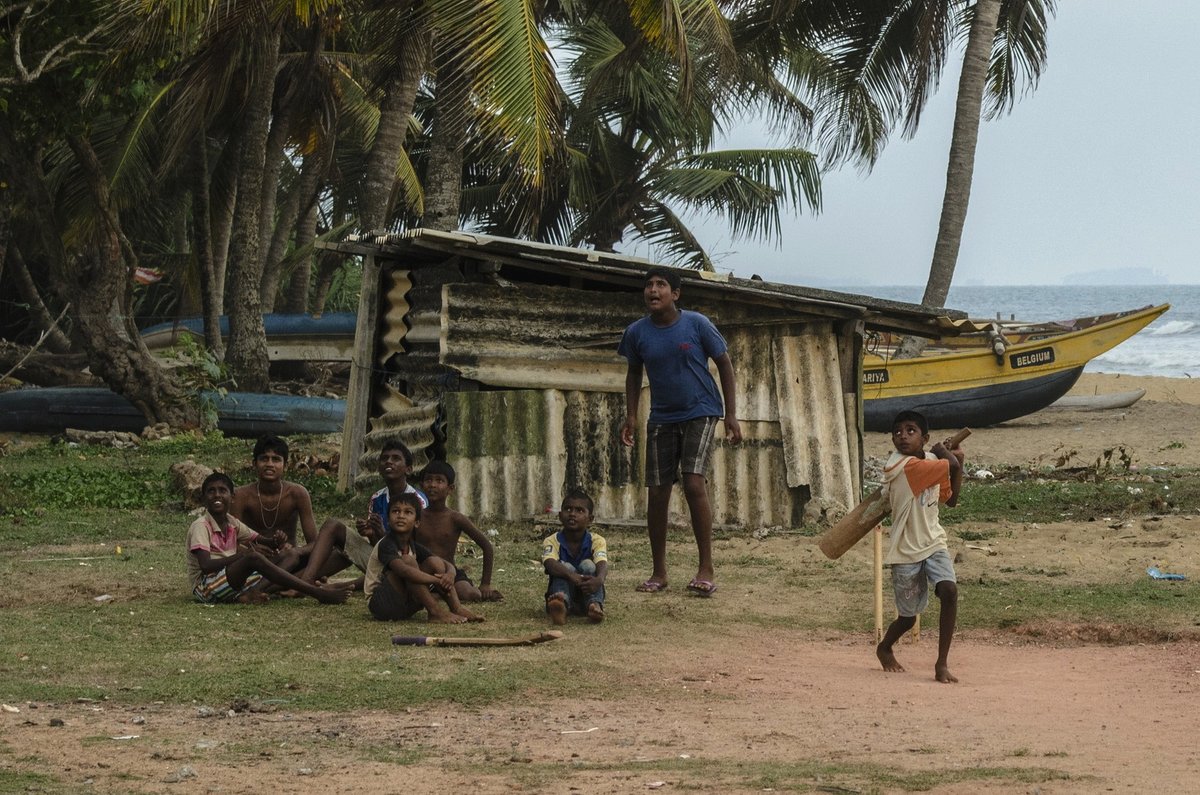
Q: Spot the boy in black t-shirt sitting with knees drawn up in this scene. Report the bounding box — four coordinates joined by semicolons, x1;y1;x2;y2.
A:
364;494;484;623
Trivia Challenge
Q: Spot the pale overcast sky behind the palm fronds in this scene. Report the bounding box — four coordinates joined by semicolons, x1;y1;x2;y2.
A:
628;0;1200;286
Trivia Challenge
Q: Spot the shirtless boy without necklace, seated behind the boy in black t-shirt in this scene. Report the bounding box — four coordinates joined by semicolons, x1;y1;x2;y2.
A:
416;461;504;602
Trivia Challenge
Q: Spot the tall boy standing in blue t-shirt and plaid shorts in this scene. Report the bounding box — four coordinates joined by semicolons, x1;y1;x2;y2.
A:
617;268;742;597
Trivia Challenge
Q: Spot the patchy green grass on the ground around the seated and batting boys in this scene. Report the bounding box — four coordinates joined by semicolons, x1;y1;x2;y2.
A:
0;436;1200;793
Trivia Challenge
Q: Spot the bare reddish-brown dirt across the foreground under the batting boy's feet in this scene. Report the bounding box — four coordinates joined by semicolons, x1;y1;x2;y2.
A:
0;630;1200;793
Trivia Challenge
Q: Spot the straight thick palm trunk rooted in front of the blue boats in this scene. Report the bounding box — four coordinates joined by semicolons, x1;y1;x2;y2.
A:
226;24;280;391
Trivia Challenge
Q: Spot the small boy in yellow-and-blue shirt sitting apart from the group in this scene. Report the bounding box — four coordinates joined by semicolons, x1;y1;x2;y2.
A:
541;489;608;624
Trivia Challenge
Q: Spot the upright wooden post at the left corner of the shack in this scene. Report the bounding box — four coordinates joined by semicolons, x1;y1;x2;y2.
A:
337;255;379;491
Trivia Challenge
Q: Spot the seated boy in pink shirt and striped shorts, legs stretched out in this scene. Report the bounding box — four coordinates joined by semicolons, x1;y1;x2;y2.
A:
187;472;346;604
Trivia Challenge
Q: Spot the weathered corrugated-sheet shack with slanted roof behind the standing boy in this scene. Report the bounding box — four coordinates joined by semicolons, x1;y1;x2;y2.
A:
321;229;964;528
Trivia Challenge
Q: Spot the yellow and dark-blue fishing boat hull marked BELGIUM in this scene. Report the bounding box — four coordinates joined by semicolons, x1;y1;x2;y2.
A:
863;304;1170;431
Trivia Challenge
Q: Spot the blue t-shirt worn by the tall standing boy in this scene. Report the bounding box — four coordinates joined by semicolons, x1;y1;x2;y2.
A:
617;310;728;424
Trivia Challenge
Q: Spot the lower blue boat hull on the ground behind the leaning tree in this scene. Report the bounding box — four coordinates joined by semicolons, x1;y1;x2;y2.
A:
0;387;346;438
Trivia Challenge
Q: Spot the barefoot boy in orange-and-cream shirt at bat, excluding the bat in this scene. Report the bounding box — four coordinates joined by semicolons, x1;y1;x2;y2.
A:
875;411;965;682
